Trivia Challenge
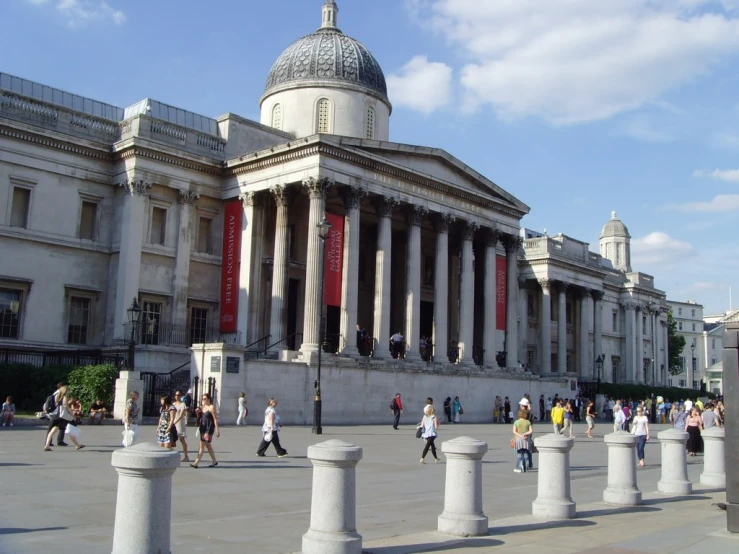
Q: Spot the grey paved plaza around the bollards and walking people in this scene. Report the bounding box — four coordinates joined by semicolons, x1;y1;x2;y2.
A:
0;420;739;554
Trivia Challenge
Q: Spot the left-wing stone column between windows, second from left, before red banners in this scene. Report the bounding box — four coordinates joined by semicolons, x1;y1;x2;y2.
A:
170;189;200;328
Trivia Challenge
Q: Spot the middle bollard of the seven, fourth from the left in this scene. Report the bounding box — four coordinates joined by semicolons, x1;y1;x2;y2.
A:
531;434;580;519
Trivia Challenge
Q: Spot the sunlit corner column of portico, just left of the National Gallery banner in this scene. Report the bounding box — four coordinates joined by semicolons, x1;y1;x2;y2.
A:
302;177;333;363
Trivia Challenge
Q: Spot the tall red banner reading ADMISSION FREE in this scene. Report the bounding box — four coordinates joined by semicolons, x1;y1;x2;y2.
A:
220;200;243;333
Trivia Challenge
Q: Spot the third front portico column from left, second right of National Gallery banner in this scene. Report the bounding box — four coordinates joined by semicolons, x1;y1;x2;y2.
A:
373;196;398;358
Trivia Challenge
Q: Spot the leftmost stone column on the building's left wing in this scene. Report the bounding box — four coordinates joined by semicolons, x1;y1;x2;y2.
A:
113;176;151;342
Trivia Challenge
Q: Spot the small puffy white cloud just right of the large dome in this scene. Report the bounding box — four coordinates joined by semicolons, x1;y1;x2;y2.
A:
387;56;453;115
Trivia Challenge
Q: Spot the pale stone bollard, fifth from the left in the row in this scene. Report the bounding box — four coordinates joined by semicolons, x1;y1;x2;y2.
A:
603;431;641;506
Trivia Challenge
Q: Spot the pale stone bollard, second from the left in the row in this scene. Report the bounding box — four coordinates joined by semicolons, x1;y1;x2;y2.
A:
303;440;362;554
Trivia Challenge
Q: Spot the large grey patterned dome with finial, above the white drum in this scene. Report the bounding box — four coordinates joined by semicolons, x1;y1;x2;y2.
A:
262;1;390;106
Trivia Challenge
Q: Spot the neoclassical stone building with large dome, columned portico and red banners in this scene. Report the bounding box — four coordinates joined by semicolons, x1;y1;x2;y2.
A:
0;0;666;390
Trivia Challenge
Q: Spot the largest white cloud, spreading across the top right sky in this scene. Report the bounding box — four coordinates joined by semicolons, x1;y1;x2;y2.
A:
408;0;739;124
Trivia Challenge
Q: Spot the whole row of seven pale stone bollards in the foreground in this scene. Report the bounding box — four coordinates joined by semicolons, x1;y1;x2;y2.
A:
112;428;726;554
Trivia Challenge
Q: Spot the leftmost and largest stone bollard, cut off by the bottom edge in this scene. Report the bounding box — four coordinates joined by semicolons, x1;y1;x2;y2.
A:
111;443;180;554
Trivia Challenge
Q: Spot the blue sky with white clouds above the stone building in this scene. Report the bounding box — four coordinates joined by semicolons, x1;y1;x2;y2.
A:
0;0;739;312
